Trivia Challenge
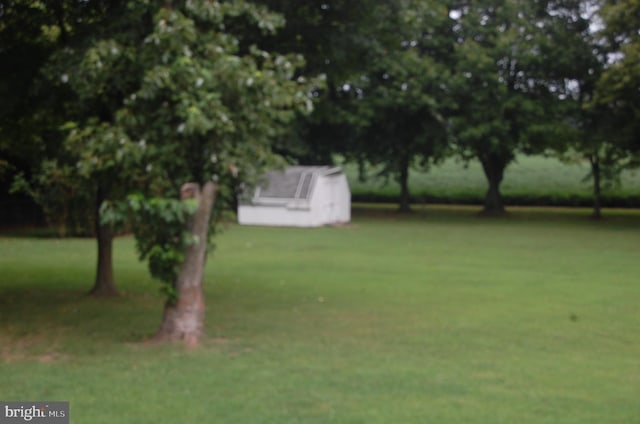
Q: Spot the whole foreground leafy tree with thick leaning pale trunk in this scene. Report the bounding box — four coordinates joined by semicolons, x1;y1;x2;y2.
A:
94;1;314;343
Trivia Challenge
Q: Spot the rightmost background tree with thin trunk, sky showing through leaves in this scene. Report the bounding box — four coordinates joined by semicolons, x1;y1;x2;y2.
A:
543;0;640;218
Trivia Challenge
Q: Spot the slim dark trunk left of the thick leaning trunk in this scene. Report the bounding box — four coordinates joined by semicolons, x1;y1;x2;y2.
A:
89;188;118;296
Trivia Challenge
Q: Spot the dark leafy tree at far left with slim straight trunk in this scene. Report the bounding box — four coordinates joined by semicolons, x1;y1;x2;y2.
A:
0;0;151;295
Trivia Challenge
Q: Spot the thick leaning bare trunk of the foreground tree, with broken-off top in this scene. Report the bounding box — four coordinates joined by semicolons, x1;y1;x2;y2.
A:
156;181;216;346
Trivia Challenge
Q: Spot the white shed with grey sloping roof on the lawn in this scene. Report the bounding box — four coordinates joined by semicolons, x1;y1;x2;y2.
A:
238;166;351;227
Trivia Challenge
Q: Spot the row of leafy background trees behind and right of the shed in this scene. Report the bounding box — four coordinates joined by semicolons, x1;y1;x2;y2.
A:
254;0;640;216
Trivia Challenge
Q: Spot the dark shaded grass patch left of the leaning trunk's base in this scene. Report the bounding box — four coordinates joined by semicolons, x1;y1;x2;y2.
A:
0;287;162;351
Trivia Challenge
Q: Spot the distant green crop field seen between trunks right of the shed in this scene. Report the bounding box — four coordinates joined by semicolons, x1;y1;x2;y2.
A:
344;156;640;206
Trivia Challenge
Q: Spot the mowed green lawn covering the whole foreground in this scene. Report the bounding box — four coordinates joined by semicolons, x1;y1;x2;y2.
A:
0;207;640;424
